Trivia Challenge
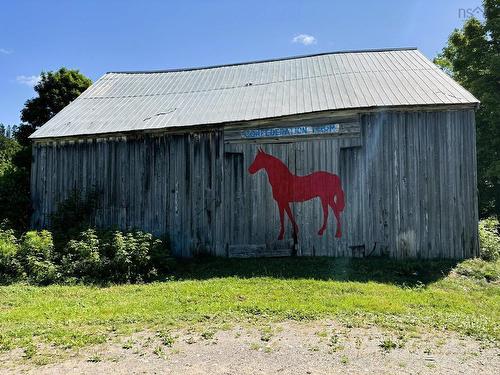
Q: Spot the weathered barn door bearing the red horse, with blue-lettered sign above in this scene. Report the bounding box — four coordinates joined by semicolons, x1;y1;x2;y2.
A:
223;122;360;257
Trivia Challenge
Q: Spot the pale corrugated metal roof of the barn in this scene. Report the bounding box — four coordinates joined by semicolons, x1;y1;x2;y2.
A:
31;49;478;138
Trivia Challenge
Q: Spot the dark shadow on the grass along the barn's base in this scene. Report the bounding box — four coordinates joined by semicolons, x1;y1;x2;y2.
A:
166;257;457;286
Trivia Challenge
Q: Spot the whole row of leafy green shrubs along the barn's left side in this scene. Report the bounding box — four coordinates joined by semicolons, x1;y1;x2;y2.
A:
0;225;172;285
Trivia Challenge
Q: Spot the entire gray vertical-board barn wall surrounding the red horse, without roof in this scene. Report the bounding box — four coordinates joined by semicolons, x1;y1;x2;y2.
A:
32;110;478;258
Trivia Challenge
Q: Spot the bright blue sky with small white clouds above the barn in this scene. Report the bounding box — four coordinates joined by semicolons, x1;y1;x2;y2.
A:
0;0;481;124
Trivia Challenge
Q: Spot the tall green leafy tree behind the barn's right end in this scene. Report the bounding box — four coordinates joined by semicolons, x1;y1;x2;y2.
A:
434;0;500;217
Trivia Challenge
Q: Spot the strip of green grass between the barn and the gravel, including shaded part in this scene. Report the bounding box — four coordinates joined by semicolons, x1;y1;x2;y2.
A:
0;258;500;350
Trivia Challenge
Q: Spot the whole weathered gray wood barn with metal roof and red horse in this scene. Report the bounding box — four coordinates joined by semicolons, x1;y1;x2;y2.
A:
31;49;478;258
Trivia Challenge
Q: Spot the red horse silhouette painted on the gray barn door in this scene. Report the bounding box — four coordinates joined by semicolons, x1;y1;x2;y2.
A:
248;149;345;241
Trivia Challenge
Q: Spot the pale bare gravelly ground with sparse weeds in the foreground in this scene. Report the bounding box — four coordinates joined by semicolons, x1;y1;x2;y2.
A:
0;321;500;375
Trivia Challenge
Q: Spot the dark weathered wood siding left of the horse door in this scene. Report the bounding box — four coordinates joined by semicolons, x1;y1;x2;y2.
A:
32;132;222;256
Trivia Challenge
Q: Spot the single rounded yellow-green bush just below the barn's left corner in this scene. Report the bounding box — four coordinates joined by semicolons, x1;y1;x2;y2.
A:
17;230;58;285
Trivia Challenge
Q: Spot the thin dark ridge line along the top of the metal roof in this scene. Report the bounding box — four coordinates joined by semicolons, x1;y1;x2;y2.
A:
106;47;417;74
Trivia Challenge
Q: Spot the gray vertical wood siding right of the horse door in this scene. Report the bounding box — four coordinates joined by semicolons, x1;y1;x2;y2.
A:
358;110;478;258
